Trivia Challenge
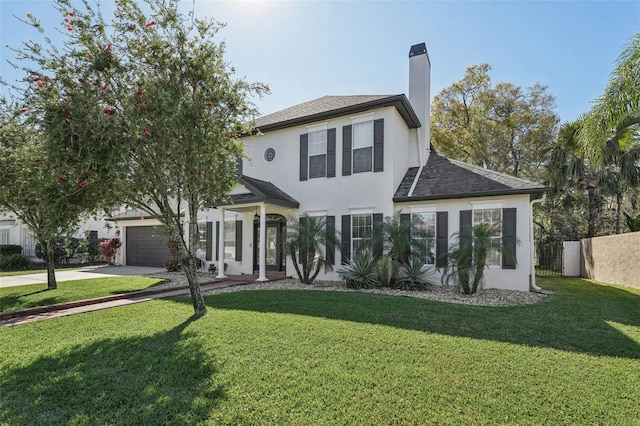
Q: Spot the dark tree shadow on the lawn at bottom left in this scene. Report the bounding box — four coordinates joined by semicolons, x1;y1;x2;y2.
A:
0;319;225;425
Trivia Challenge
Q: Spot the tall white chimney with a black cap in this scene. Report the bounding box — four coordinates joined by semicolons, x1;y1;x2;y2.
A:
409;43;431;165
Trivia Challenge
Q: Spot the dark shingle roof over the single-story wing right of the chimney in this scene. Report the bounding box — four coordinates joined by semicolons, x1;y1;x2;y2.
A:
393;152;547;202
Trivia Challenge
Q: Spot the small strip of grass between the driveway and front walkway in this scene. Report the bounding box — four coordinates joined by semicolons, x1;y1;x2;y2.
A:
0;277;163;312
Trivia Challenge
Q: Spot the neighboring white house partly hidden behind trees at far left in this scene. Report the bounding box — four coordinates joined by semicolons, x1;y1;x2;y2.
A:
0;212;114;260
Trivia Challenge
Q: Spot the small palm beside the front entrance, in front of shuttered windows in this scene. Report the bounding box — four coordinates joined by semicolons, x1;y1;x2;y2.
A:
285;214;338;284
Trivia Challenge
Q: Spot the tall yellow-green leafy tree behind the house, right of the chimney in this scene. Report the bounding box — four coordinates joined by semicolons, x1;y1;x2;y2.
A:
431;64;559;180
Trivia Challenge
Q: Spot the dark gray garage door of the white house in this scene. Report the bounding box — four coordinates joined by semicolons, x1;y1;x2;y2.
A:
126;226;169;267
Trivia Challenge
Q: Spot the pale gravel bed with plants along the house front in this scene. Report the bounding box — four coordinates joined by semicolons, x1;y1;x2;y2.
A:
148;272;546;306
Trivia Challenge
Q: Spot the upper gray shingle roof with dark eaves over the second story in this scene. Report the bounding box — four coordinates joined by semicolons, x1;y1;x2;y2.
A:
256;95;421;132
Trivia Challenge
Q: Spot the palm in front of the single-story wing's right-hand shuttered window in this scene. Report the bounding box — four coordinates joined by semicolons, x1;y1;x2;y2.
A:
442;223;504;294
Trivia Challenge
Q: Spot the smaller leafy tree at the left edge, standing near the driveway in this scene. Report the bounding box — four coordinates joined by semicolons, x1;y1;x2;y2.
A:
0;111;100;290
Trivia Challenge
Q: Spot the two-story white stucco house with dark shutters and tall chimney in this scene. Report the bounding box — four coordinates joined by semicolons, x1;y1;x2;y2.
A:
116;43;545;290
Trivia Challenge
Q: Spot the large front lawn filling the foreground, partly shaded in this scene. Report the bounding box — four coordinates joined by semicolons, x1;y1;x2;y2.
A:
0;278;640;425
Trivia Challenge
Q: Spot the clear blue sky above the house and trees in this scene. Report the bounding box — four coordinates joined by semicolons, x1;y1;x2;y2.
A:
0;0;640;121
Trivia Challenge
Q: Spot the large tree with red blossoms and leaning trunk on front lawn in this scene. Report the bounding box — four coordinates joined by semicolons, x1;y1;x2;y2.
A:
3;0;267;316
